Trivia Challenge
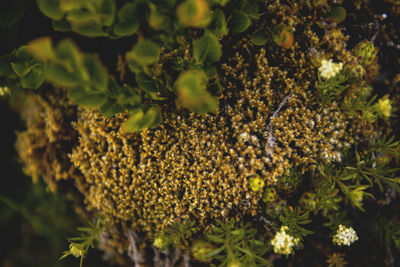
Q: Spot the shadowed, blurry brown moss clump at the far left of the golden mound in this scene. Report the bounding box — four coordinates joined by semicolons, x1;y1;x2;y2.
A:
15;89;78;191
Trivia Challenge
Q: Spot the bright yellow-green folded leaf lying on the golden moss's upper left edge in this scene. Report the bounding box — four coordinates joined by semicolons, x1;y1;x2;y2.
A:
121;105;162;132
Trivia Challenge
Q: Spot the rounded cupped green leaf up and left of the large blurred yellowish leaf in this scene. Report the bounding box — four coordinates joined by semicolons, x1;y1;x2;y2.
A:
126;40;160;66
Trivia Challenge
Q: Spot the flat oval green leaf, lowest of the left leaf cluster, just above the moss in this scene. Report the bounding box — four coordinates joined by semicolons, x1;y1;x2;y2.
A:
69;87;107;108
